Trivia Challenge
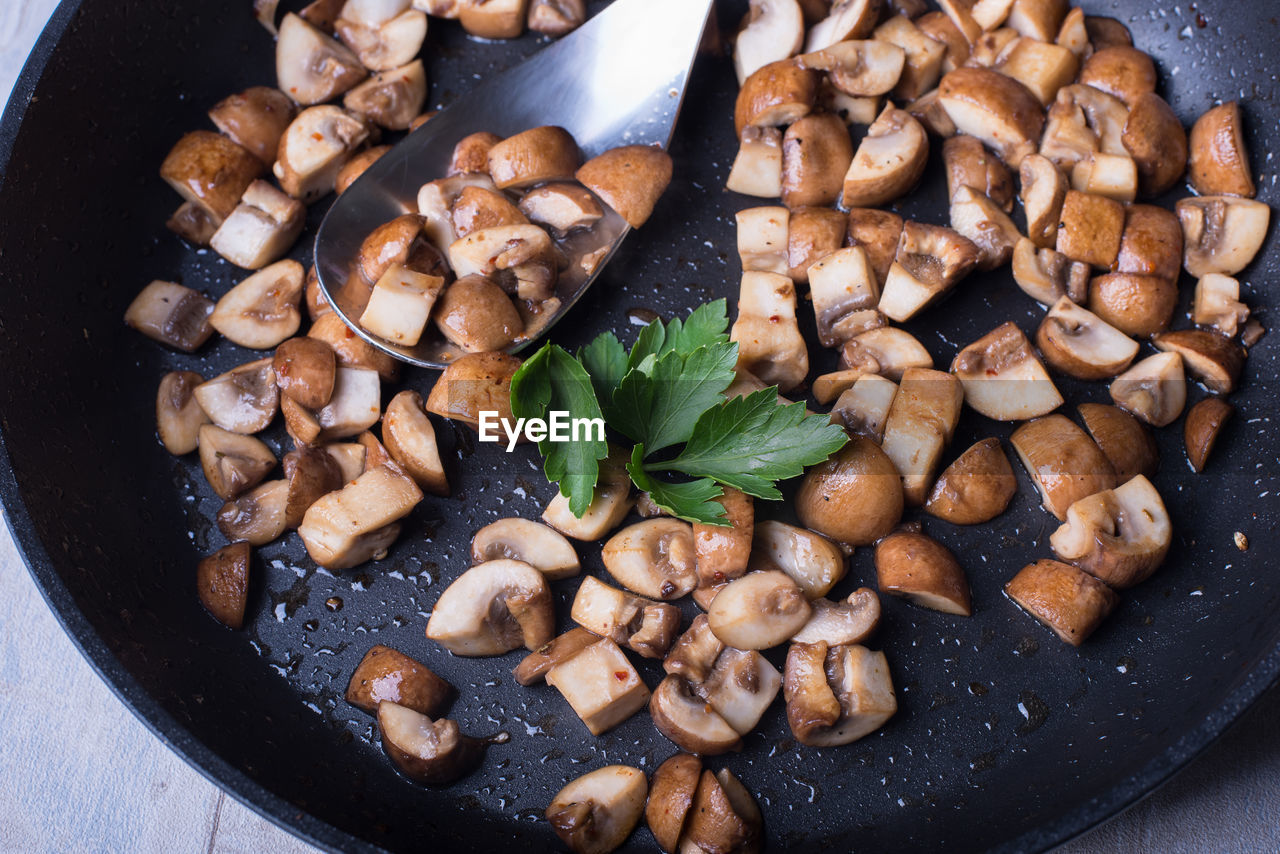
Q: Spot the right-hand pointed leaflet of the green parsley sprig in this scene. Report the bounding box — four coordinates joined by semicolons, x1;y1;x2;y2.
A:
645;388;849;501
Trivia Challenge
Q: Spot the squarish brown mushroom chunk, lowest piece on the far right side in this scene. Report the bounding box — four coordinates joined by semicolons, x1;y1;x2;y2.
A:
1005;561;1120;647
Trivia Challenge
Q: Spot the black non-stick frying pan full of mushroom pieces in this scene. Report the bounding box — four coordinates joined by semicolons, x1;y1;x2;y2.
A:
0;0;1280;851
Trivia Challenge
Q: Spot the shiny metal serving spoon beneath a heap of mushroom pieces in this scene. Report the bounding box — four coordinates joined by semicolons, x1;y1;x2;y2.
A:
307;0;713;369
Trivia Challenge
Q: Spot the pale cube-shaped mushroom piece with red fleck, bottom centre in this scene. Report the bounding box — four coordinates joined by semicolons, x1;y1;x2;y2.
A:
545;640;655;735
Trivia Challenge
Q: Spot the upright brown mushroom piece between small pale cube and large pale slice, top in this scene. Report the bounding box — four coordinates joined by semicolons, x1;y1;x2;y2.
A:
782;113;854;208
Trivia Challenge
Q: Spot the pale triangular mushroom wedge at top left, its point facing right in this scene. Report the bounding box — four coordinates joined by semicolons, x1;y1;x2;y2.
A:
275;13;369;106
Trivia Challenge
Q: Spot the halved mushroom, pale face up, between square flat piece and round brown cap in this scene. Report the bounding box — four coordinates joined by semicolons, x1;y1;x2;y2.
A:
1036;297;1138;379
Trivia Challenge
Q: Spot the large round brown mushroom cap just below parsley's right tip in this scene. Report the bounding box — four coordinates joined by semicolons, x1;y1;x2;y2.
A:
796;437;904;545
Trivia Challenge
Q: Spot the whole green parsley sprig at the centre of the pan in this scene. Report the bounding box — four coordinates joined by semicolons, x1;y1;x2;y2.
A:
511;300;847;525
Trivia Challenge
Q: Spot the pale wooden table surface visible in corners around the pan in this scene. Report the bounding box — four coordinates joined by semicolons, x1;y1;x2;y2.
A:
0;0;1280;854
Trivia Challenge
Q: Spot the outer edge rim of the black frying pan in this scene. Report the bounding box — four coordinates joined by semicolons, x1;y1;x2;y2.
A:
0;0;1280;851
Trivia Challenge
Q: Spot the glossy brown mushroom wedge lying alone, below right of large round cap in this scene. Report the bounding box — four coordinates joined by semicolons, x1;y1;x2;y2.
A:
876;531;973;617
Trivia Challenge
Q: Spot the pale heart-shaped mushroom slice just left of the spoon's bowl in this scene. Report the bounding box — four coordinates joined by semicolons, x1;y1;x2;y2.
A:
209;258;306;348
